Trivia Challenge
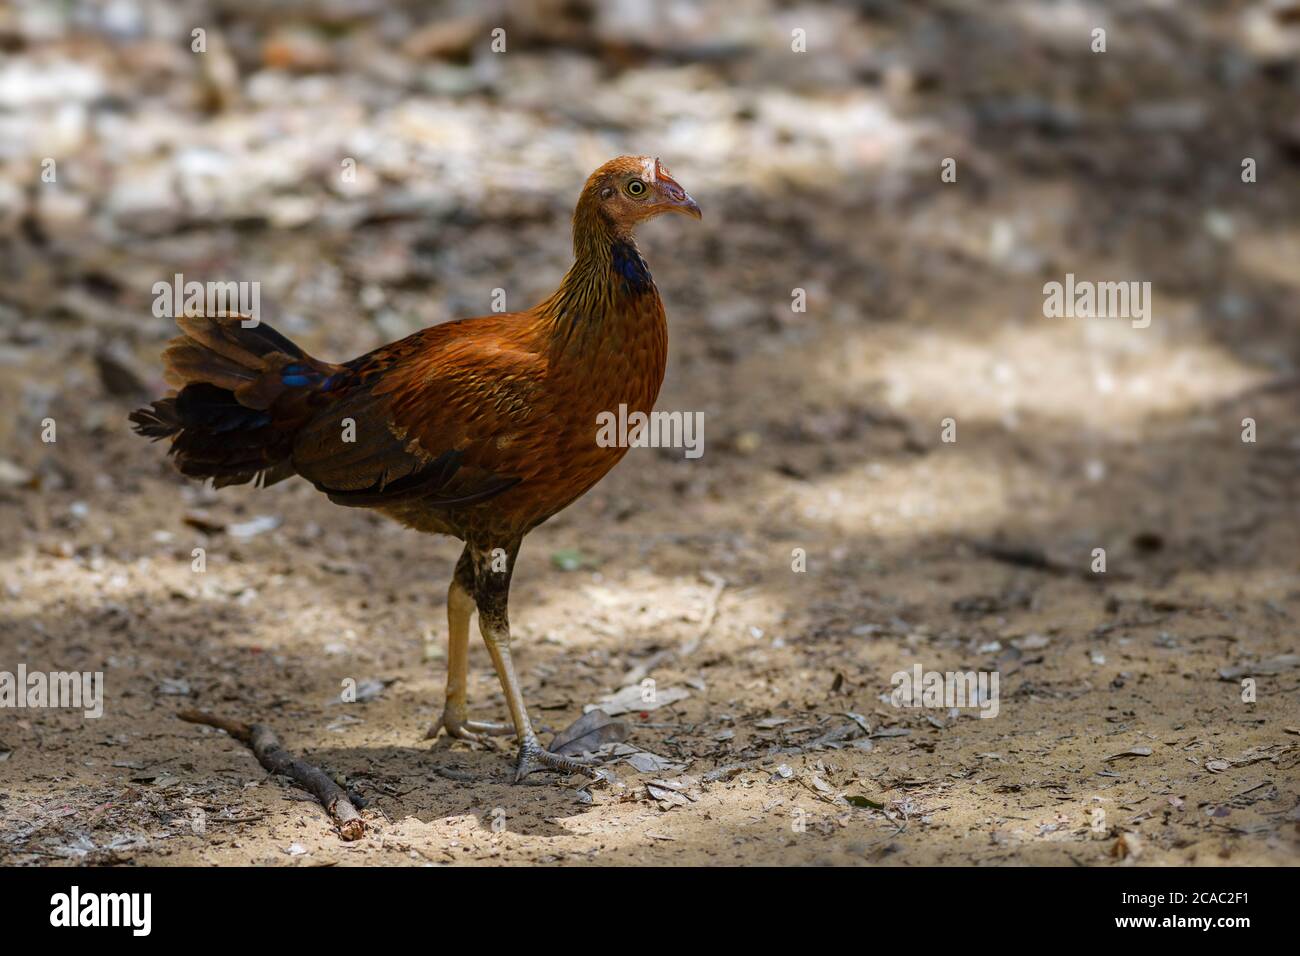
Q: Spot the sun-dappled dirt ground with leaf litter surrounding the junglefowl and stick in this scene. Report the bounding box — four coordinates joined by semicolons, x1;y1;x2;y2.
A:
0;3;1300;866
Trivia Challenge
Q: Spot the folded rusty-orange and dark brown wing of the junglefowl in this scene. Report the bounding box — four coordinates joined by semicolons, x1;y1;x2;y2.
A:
293;320;545;507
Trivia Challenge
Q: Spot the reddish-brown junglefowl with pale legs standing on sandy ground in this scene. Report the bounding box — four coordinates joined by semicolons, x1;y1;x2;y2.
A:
131;156;699;782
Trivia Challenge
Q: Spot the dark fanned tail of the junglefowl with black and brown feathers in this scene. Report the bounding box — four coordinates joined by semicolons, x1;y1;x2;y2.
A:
130;316;345;488
